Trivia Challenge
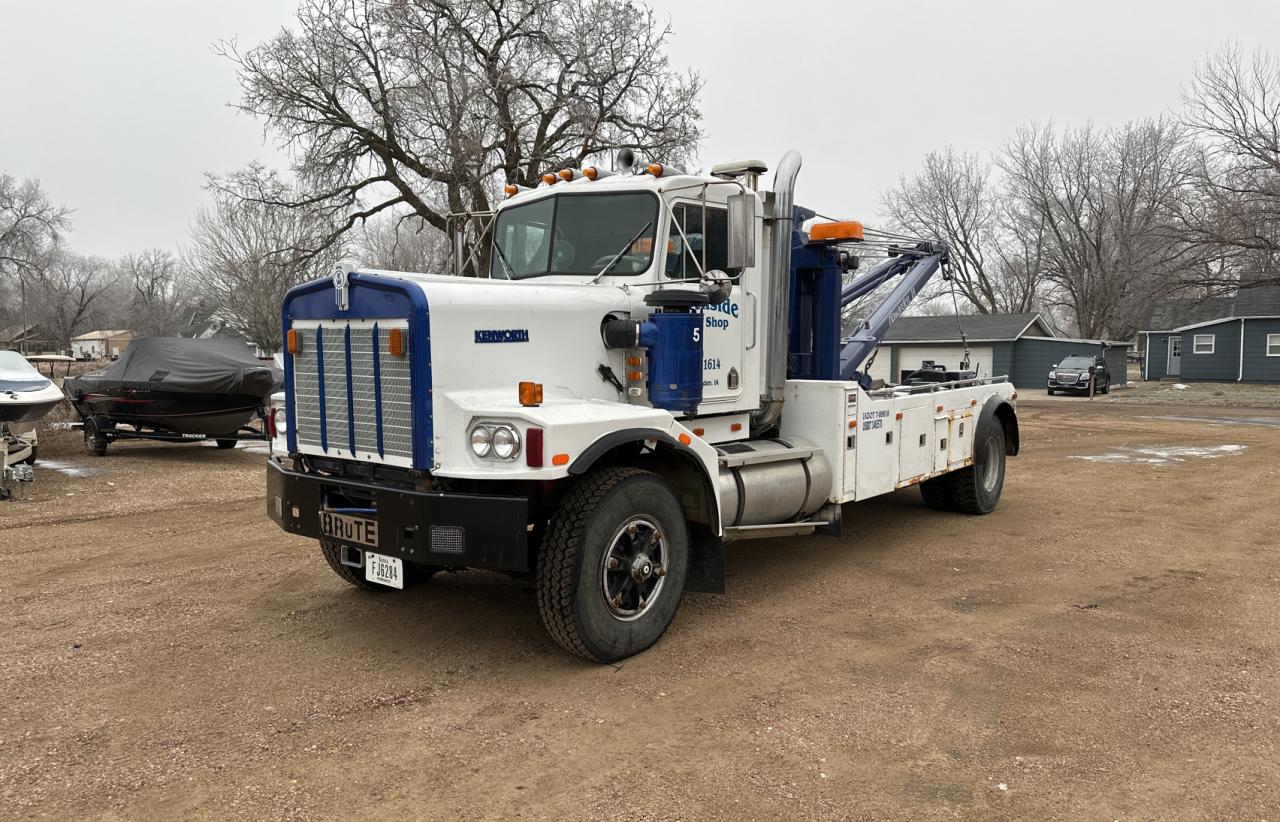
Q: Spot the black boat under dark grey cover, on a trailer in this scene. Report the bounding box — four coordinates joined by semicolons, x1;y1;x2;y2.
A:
63;337;279;435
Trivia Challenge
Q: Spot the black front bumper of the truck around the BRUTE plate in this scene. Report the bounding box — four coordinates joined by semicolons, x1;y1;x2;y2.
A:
266;461;530;572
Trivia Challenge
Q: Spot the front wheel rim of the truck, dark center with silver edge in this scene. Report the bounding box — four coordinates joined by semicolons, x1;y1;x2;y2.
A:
600;515;668;622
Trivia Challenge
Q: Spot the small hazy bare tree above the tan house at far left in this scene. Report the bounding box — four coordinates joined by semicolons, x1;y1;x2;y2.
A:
27;246;115;350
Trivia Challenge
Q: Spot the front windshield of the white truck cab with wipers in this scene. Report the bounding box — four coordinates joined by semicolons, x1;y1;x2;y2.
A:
489;192;658;279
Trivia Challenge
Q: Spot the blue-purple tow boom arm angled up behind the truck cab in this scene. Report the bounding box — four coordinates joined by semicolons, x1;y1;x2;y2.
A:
840;243;947;388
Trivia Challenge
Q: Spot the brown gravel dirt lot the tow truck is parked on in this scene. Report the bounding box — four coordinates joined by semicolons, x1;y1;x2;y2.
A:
0;398;1280;819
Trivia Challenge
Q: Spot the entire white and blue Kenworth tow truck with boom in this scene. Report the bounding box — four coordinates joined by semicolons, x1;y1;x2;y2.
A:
268;151;1019;662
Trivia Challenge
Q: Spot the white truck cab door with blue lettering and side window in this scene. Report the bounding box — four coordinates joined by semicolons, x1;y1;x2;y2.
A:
667;202;754;406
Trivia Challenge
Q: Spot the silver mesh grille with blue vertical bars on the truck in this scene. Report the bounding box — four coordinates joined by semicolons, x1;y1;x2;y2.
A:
293;320;413;465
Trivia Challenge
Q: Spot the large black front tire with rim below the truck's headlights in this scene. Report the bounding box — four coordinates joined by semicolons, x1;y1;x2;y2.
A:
538;467;689;662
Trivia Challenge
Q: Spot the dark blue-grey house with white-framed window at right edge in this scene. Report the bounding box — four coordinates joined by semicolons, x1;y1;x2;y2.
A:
1138;286;1280;383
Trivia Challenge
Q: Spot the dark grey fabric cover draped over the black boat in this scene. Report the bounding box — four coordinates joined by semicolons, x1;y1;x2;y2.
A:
68;337;282;398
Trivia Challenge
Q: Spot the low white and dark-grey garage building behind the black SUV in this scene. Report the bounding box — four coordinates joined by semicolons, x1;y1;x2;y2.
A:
868;314;1132;388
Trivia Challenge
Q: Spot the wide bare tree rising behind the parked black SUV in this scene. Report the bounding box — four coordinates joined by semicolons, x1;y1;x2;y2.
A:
1000;120;1196;337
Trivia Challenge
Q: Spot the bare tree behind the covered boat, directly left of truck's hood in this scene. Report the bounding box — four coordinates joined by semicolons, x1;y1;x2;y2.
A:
184;183;338;351
